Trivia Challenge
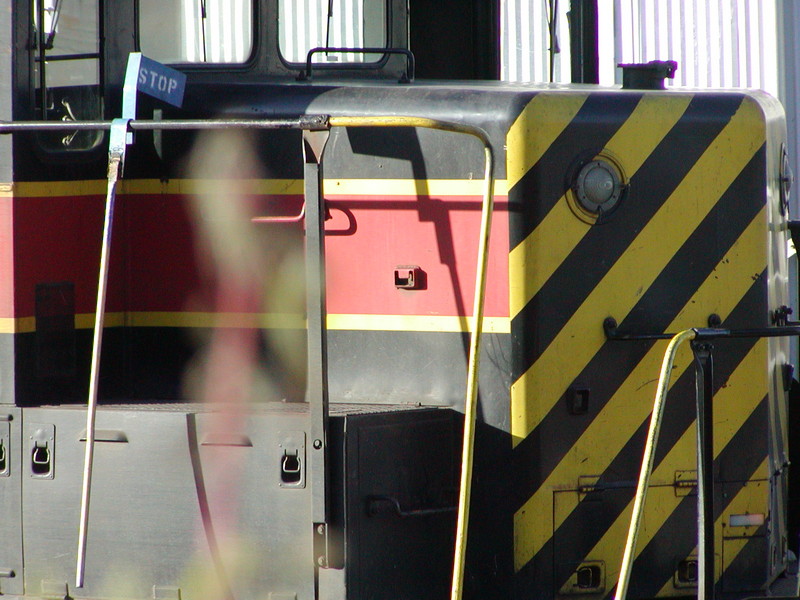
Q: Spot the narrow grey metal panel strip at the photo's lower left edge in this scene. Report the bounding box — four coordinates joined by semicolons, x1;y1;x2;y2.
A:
0;407;23;595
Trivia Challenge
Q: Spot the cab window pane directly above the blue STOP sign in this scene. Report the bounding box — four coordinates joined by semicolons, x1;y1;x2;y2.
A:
139;0;253;63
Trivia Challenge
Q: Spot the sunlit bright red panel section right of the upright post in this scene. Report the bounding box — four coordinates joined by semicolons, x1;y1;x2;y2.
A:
326;196;509;317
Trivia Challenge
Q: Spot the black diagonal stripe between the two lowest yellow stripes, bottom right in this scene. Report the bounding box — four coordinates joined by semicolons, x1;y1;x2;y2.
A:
620;396;769;598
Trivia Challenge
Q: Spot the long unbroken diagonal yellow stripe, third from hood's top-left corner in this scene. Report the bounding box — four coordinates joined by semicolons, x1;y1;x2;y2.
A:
511;98;764;444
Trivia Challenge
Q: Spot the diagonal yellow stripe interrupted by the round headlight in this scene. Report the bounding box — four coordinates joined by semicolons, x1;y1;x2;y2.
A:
508;95;693;318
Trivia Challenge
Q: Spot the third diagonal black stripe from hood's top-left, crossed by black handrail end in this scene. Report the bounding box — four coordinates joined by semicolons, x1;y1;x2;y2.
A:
513;151;766;507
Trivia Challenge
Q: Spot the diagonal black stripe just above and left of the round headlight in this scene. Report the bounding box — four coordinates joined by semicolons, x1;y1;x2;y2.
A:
508;92;642;248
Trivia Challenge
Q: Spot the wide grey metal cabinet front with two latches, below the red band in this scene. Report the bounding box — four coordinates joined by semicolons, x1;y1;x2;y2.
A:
23;406;314;600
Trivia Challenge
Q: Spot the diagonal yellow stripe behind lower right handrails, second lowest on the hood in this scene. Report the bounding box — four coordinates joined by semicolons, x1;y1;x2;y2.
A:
587;341;767;596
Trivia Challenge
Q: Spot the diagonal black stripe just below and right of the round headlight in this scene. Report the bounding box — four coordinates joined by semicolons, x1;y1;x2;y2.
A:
511;96;744;380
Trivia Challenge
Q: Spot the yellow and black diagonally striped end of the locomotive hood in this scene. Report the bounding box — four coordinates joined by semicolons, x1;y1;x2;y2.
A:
507;90;785;598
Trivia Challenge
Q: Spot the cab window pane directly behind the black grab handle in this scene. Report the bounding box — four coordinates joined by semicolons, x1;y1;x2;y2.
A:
278;0;386;63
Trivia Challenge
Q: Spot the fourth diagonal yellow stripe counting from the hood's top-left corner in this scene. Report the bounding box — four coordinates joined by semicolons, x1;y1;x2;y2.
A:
514;208;767;570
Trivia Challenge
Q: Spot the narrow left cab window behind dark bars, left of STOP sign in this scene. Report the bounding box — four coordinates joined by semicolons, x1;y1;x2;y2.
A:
33;0;103;150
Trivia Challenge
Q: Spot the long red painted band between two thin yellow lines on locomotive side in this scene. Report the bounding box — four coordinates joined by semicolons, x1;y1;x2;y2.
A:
9;194;508;324
